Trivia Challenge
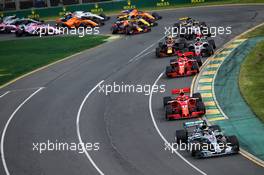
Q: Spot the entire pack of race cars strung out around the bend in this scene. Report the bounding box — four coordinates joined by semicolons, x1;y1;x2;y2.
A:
0;9;239;158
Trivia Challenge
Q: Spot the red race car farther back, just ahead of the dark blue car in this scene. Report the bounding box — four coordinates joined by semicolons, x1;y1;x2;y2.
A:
165;52;202;78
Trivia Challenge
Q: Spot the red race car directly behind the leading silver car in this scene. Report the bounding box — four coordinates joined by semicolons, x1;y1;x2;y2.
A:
163;88;206;120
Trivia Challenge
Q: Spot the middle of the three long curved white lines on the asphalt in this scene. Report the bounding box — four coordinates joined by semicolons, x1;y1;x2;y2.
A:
76;80;104;175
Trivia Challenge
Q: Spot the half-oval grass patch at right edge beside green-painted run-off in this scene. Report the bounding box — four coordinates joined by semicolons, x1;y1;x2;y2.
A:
239;41;264;122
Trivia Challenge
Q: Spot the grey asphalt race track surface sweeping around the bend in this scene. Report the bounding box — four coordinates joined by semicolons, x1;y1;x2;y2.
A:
0;6;264;175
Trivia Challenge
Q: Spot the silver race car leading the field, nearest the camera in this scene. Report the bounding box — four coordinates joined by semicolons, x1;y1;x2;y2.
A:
176;120;239;158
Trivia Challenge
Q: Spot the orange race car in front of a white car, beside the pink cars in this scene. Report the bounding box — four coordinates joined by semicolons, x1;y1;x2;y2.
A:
56;16;99;28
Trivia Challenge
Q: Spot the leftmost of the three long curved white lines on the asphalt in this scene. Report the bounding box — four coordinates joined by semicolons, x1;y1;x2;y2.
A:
1;87;43;175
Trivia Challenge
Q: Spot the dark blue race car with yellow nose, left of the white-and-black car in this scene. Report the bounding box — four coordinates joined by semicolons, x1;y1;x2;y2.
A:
156;36;187;58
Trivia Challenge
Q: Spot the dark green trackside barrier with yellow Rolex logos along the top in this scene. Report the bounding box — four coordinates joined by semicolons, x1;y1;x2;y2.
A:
0;0;220;17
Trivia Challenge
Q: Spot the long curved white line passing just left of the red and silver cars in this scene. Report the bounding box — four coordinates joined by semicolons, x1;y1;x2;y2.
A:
149;72;206;175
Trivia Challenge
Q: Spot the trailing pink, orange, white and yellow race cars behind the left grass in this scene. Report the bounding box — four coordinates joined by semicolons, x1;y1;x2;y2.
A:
0;9;162;37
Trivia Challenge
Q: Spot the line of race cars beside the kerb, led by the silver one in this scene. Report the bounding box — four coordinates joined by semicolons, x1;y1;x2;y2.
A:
160;17;239;158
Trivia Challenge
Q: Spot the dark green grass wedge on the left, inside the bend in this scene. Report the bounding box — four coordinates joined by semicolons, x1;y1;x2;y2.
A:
0;36;108;85
